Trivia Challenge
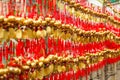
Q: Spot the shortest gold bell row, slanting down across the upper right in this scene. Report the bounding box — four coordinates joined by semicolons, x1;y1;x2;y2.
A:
58;0;120;27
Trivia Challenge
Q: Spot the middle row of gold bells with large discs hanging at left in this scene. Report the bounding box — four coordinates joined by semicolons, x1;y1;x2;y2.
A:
0;16;120;43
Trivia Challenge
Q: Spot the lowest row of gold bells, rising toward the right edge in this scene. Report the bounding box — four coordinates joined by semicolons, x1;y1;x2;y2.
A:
0;49;120;79
